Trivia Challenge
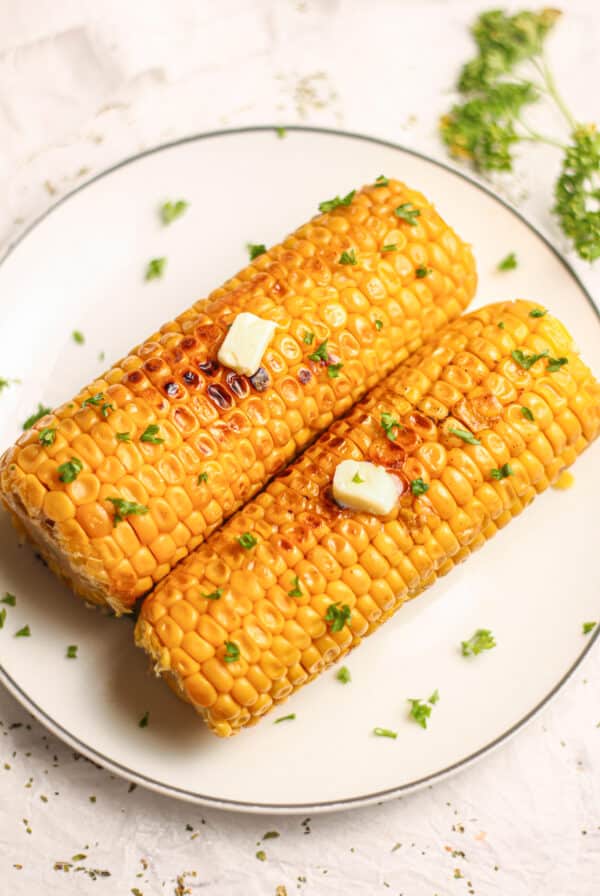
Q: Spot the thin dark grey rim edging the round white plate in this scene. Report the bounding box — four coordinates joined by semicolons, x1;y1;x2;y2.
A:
0;124;600;815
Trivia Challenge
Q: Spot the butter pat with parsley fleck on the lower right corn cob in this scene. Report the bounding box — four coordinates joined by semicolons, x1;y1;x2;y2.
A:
333;460;400;516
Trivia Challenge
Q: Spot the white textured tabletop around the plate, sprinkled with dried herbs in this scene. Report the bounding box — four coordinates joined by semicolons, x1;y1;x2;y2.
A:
0;0;600;896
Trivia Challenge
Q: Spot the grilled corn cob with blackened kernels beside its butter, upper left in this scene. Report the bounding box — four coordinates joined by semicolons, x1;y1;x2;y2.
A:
0;179;476;612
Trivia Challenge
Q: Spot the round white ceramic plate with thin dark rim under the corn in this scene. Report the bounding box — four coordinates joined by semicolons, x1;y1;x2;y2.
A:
0;128;600;812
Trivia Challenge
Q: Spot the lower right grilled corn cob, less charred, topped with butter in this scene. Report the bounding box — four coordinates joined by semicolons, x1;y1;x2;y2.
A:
136;301;600;736
